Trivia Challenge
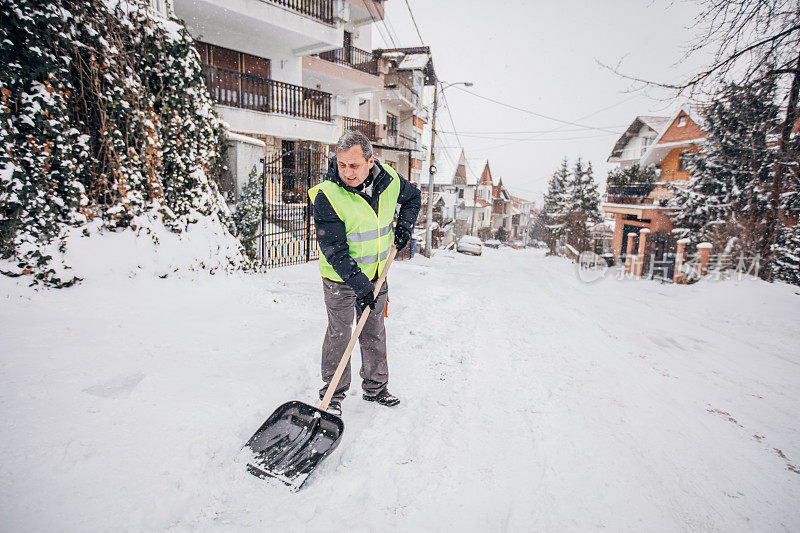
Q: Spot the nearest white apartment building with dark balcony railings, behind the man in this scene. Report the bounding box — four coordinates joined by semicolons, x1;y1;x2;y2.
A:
173;0;384;201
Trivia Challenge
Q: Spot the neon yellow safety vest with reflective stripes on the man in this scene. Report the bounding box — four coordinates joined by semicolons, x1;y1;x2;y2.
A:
308;163;400;282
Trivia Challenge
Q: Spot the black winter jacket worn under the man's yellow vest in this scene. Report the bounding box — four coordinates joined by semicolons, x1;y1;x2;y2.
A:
314;156;421;298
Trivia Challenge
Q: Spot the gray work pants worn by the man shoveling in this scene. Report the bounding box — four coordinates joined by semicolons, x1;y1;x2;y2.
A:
319;278;389;401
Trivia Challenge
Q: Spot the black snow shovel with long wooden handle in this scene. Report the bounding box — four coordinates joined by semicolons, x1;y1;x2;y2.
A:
245;245;397;491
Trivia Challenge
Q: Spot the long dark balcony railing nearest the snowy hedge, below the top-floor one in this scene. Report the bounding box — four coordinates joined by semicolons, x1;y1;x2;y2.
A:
203;65;331;122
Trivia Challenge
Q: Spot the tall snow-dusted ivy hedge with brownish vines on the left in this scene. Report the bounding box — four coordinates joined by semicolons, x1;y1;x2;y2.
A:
0;0;245;286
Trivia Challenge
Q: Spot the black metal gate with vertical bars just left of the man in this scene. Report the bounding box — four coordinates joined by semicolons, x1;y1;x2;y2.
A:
259;147;327;268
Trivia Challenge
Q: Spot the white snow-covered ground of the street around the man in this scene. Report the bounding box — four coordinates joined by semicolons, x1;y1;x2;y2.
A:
0;249;800;531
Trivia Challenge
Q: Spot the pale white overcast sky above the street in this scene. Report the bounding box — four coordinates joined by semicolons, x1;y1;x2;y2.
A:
373;0;700;204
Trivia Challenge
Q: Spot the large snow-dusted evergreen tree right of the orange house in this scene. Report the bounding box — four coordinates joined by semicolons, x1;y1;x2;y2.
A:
672;79;780;277
